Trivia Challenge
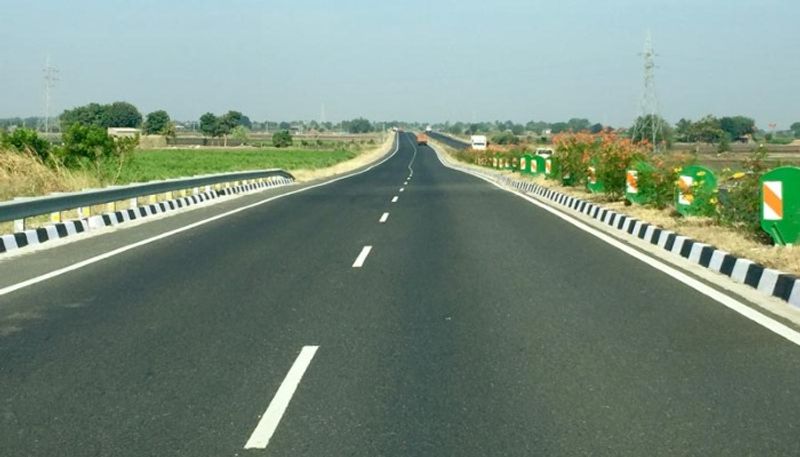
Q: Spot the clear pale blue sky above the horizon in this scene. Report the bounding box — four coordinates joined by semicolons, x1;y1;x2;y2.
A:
0;0;800;128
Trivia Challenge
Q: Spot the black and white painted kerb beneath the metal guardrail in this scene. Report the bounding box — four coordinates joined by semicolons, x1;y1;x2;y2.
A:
0;176;294;253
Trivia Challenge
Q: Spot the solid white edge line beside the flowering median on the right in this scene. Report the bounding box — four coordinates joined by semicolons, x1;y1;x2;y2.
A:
437;146;800;346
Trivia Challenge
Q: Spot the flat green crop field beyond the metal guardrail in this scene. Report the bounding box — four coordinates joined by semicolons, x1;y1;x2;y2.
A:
118;148;358;184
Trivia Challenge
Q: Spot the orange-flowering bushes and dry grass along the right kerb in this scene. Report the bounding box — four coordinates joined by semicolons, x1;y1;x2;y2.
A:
440;131;800;275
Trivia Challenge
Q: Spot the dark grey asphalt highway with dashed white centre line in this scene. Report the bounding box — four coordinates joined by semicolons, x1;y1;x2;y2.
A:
0;134;800;457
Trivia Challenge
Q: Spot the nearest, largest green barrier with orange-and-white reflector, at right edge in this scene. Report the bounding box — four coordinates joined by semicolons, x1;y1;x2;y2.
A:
760;167;800;246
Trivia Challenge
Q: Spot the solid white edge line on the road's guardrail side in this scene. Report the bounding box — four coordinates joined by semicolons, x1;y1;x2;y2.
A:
0;134;400;296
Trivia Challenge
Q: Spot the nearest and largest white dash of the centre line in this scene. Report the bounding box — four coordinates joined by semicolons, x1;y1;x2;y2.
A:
244;346;319;449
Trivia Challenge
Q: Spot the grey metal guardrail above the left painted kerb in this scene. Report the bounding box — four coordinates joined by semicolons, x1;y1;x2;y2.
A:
0;169;294;222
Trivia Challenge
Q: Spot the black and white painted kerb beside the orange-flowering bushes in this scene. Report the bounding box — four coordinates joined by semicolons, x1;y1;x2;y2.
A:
437;152;800;308
